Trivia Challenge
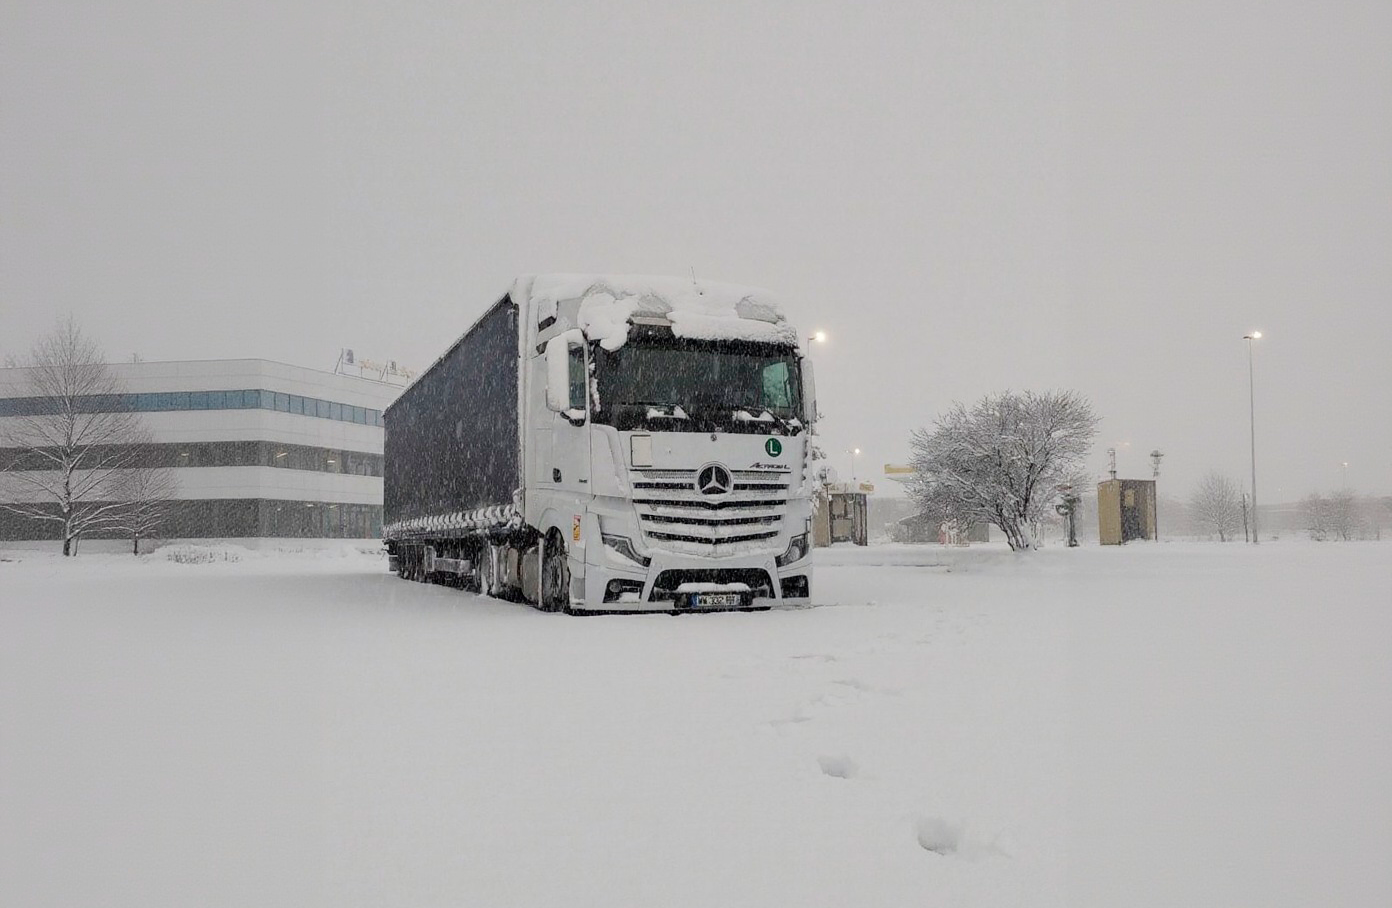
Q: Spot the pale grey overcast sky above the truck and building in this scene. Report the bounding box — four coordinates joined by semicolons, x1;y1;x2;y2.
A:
0;0;1392;501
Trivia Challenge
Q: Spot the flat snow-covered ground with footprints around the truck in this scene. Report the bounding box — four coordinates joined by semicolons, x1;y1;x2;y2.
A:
0;542;1392;908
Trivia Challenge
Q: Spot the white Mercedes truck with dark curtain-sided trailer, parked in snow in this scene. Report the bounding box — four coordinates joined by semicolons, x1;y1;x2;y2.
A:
383;274;816;613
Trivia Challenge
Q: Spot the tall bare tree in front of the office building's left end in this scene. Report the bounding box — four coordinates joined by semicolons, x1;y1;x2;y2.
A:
0;318;141;556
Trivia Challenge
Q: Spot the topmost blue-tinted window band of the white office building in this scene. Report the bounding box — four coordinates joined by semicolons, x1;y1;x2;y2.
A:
0;389;383;428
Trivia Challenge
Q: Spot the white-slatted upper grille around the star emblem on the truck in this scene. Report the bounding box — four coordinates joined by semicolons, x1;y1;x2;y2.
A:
633;469;789;556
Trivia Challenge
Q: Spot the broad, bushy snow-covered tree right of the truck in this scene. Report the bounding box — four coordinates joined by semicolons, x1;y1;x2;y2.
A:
909;391;1097;551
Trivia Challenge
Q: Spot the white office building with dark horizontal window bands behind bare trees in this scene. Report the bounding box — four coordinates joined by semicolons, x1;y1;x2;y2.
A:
0;359;401;540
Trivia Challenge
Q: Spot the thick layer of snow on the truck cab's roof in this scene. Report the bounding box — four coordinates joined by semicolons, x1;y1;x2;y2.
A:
512;274;798;350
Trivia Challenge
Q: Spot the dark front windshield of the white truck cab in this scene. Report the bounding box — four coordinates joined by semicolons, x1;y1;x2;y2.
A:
594;331;802;433
